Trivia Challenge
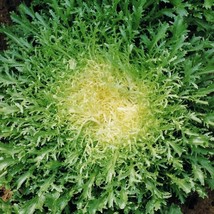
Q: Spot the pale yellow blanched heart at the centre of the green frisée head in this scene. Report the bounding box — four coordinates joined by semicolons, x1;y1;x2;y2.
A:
56;60;157;144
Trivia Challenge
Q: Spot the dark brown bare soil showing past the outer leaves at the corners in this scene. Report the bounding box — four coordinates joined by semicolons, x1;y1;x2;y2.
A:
0;0;214;214
